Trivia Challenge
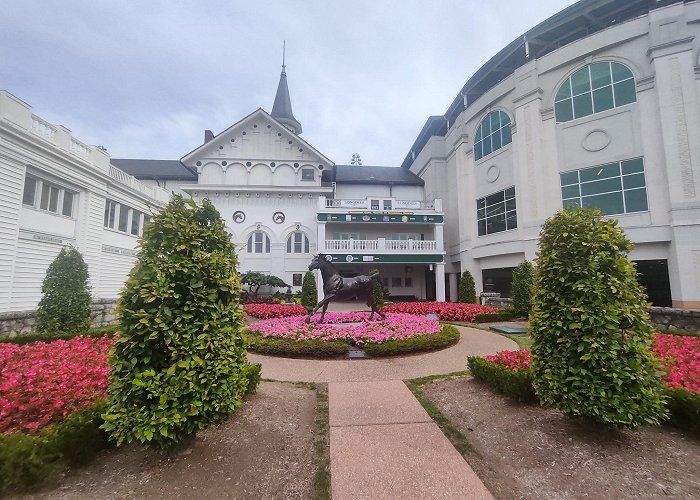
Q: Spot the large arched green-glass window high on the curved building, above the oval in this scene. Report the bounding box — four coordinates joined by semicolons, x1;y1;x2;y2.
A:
554;61;637;122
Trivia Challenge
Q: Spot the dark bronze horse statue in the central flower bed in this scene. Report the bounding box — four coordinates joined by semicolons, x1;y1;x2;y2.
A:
306;254;386;323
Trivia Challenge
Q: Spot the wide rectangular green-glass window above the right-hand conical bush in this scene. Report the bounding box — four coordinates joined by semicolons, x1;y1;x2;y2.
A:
560;158;649;215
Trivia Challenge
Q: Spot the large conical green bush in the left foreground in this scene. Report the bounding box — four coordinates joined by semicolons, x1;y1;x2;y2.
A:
103;196;248;449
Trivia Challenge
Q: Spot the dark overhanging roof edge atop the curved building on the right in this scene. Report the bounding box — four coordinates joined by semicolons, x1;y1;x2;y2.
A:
401;0;687;168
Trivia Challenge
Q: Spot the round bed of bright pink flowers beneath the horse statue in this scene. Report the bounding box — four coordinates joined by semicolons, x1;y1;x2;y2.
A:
250;312;442;345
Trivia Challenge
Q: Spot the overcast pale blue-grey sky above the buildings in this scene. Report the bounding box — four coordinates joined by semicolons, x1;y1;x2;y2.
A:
0;0;575;166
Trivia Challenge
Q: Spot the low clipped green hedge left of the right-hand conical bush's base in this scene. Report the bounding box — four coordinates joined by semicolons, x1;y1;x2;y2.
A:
467;356;538;403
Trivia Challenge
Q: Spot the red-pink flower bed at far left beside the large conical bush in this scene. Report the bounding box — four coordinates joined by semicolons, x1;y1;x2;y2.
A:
0;337;112;433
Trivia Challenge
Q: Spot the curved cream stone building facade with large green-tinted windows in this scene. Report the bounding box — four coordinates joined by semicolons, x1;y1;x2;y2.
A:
405;2;700;308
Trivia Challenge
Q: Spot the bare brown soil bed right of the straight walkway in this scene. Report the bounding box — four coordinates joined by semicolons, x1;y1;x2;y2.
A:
421;377;700;499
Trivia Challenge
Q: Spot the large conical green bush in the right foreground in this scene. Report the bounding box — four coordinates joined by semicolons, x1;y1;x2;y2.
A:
531;209;665;428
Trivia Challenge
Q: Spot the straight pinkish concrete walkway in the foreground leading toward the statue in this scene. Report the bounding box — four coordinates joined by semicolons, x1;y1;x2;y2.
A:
328;380;493;500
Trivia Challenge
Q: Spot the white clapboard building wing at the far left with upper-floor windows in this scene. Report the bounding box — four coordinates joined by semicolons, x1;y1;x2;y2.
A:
0;91;169;312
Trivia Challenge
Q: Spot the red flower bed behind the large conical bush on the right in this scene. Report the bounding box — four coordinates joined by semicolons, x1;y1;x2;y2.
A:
484;333;700;393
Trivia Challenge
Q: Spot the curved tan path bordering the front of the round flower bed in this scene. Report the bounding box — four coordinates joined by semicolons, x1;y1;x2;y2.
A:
248;326;518;382
